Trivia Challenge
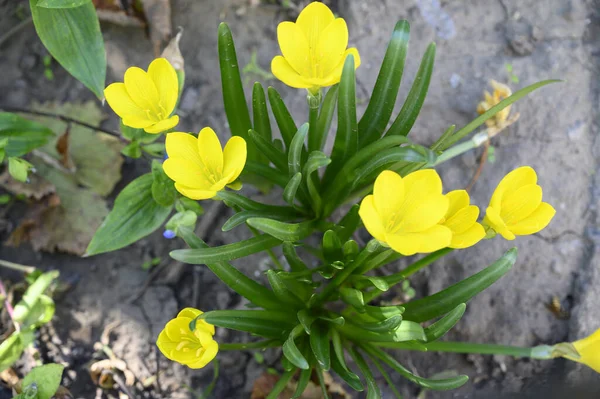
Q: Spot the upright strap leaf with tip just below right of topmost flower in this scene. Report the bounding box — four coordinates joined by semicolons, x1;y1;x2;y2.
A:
323;55;358;184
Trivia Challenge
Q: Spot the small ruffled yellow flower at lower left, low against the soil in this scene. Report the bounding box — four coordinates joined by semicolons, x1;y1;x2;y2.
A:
156;308;219;369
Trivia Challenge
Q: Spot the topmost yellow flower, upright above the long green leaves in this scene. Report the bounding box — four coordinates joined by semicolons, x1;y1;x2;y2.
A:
271;1;360;91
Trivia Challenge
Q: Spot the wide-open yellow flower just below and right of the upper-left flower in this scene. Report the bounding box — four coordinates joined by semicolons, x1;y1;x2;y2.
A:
163;127;247;200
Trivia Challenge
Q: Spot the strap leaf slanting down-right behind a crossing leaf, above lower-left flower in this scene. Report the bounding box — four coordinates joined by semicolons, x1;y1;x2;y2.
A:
177;227;281;309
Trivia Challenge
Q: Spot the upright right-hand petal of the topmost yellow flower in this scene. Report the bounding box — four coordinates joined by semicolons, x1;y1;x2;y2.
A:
314;18;356;77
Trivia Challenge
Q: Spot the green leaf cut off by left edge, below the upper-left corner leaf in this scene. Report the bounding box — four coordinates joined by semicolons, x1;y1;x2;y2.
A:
0;112;54;157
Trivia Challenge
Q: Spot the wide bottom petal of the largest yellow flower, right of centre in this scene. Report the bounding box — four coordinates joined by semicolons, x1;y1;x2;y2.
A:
386;224;452;256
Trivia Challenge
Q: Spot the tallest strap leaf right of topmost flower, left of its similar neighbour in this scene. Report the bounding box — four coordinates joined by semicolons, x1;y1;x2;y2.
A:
358;21;410;145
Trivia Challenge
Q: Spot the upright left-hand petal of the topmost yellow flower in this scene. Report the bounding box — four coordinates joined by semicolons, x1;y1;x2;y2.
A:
277;22;313;76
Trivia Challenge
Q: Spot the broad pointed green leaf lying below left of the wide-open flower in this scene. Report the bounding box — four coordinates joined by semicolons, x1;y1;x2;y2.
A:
86;173;172;256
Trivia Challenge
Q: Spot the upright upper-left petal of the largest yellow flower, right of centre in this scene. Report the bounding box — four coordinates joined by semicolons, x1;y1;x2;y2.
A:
373;170;404;230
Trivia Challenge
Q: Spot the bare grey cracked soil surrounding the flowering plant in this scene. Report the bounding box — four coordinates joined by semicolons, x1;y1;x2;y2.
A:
0;0;600;399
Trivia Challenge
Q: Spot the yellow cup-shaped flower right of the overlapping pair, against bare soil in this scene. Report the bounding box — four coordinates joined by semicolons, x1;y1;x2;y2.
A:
483;166;556;240
